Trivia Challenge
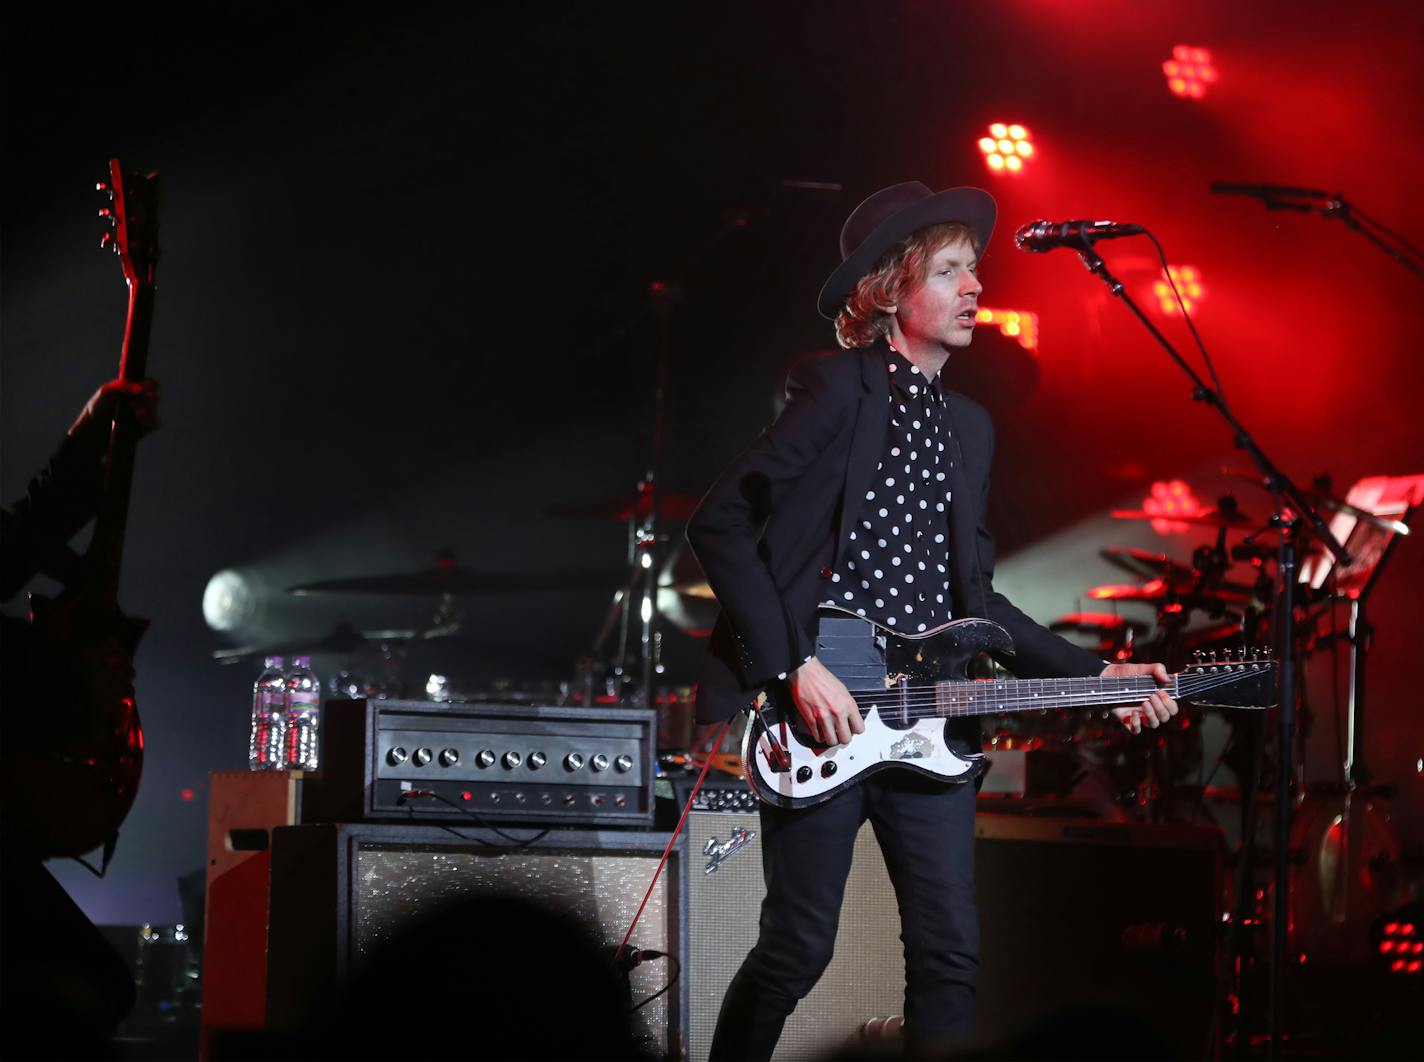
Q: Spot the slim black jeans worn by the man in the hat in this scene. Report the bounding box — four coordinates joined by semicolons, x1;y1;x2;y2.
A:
709;770;978;1062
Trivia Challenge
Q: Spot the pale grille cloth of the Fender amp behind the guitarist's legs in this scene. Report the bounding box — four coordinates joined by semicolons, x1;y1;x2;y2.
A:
684;811;904;1062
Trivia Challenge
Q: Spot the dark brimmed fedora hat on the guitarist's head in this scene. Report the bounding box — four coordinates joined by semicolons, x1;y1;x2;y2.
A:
816;181;995;320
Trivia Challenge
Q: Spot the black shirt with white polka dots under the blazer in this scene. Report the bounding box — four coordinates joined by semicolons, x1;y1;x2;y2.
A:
826;347;951;633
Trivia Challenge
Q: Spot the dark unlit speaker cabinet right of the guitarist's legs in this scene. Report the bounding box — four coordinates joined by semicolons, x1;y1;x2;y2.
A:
974;813;1222;1058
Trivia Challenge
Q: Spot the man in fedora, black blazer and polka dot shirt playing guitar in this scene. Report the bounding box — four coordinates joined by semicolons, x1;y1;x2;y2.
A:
688;182;1176;1059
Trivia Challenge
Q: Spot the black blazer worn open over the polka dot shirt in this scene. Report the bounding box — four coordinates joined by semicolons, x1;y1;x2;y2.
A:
688;340;1104;723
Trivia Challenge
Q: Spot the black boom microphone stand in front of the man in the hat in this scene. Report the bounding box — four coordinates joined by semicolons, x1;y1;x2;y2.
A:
1078;233;1350;1059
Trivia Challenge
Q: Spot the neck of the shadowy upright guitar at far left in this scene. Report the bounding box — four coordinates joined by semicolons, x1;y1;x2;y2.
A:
85;283;154;606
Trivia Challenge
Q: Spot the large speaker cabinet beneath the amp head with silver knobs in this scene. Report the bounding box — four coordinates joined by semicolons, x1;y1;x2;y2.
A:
268;824;688;1058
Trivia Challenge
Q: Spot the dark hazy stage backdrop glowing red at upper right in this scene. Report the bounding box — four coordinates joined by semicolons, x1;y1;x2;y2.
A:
8;0;1424;922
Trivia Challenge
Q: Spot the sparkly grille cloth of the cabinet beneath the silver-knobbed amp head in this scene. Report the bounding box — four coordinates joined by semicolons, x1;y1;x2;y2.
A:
352;843;669;1058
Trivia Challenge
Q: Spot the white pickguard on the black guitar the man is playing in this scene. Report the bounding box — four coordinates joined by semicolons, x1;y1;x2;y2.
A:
742;709;981;800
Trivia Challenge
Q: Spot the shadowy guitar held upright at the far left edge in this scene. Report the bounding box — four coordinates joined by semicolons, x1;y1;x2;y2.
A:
13;158;158;866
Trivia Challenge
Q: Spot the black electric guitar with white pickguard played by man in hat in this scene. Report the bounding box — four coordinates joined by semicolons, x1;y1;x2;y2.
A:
742;609;1276;807
